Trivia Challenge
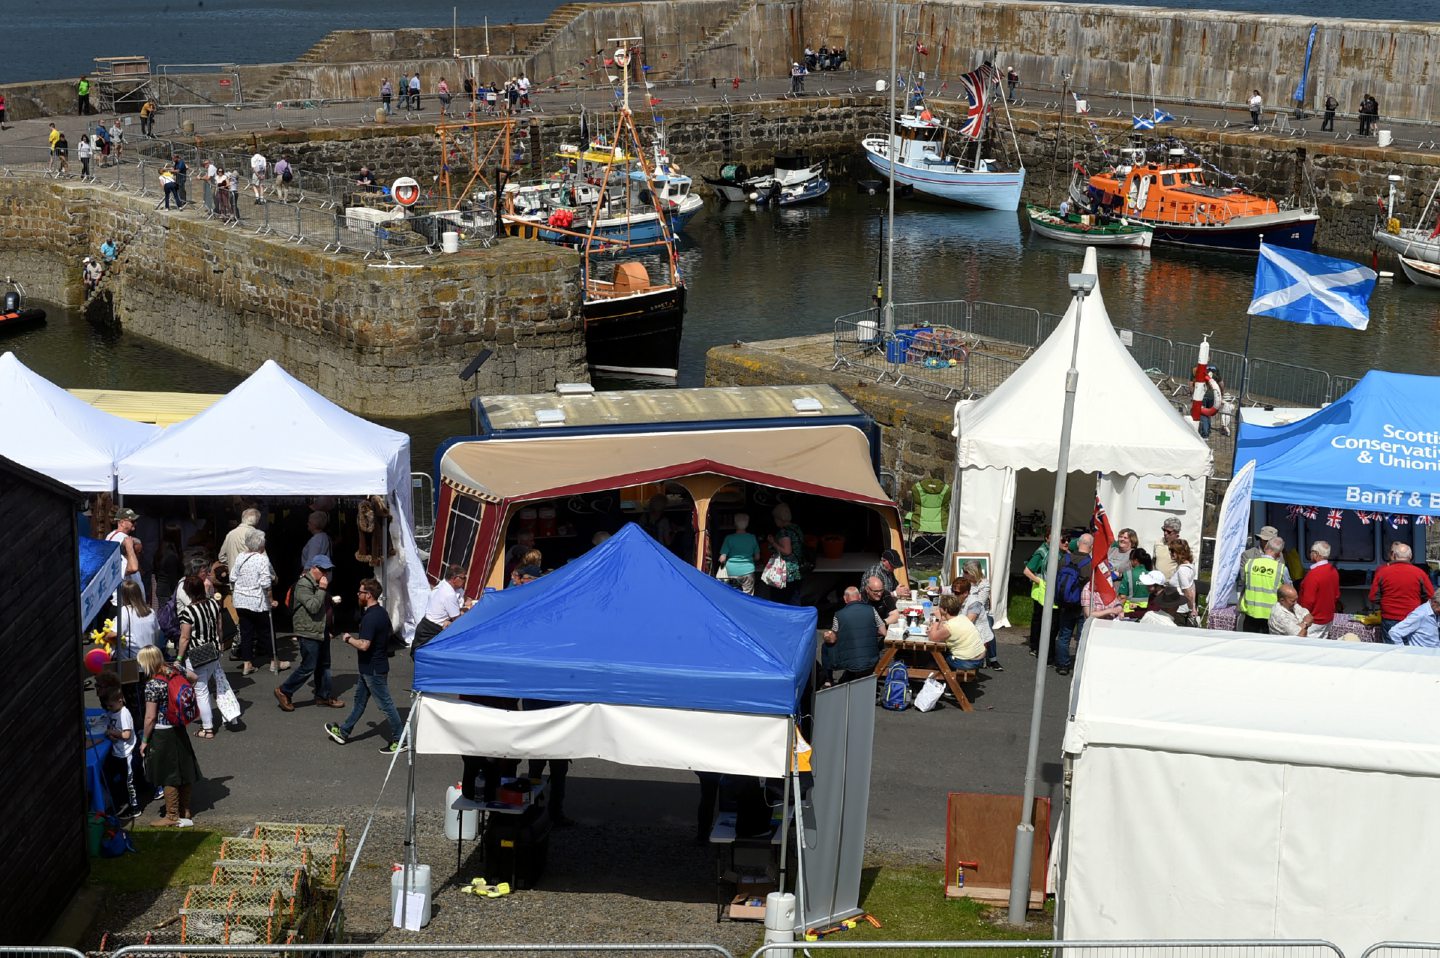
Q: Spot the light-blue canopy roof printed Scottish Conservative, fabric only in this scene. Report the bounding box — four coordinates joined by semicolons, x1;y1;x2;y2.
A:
1236;370;1440;516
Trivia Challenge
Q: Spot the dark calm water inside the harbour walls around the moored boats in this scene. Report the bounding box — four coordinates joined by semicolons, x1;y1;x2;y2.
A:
11;187;1440;471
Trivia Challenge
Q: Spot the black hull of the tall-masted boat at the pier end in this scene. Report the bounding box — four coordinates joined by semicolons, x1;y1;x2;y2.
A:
580;285;685;379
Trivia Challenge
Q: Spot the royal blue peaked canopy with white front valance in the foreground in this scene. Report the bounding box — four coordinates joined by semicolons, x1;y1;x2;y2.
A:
415;524;815;776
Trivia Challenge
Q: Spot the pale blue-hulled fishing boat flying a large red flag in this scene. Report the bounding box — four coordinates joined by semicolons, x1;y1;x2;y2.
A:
861;62;1025;212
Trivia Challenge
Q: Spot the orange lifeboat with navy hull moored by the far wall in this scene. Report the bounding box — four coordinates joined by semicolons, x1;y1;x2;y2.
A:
1070;143;1320;252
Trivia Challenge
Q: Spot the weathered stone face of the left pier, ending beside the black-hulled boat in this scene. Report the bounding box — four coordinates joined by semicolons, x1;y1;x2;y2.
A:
0;179;586;416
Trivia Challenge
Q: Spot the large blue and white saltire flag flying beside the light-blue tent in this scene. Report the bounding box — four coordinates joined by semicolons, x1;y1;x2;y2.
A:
1248;243;1375;330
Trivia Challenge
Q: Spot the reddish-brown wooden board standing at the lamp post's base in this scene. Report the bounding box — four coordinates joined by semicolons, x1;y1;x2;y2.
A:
945;792;1050;908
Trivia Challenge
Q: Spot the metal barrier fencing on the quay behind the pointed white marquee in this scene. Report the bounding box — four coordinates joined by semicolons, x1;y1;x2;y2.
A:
834;300;1359;406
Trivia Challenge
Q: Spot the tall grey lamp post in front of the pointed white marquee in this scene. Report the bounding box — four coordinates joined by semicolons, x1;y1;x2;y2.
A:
1009;272;1099;925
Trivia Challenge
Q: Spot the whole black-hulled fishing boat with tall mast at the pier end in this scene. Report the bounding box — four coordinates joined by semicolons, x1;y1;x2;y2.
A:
580;37;685;379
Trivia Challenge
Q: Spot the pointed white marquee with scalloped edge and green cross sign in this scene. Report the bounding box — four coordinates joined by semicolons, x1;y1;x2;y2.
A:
946;249;1212;625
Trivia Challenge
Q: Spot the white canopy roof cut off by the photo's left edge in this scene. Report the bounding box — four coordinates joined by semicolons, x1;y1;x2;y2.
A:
0;353;158;493
